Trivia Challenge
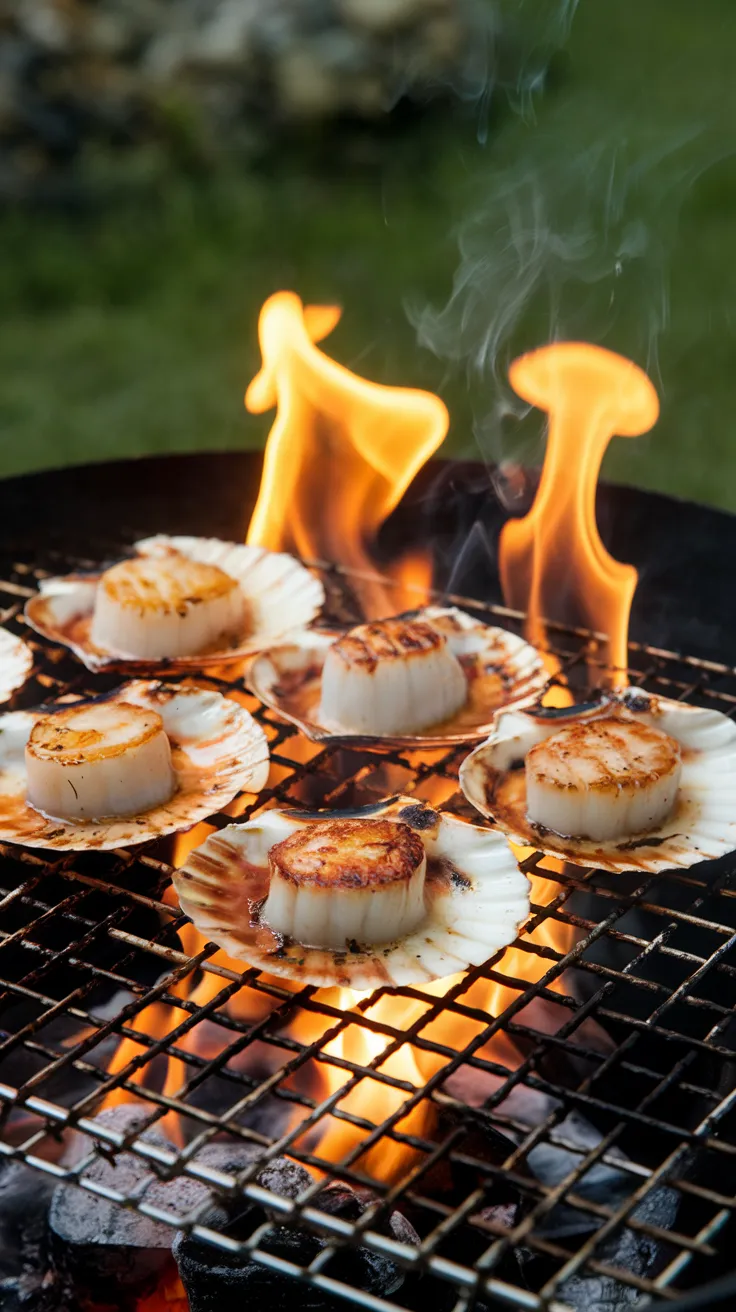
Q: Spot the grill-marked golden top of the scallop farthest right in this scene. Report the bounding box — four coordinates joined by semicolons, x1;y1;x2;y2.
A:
526;715;680;792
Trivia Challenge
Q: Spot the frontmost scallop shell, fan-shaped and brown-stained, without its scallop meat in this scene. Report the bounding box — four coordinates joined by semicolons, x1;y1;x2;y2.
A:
173;796;529;989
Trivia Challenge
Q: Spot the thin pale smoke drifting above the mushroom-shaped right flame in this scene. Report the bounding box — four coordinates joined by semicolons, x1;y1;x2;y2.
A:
405;129;712;459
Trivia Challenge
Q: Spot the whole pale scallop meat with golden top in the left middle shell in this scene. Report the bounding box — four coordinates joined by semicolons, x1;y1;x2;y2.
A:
25;701;176;820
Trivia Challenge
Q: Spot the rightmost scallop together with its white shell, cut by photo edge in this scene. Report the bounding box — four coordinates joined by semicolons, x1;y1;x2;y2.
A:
460;689;736;872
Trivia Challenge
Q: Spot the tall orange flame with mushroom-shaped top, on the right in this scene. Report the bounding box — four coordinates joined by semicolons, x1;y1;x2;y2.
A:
500;342;659;685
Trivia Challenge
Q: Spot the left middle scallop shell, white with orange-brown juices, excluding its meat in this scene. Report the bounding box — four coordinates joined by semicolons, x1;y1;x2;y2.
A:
0;680;269;851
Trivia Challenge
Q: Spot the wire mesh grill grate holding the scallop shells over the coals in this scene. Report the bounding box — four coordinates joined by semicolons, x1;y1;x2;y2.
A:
0;548;736;1312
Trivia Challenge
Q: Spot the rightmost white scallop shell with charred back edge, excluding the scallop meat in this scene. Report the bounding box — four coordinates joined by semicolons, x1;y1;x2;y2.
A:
460;689;736;874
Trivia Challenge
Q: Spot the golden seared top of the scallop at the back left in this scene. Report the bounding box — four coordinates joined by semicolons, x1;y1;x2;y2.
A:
100;552;239;615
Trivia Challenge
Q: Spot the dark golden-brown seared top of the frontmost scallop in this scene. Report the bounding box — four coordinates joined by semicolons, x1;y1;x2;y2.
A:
269;820;425;888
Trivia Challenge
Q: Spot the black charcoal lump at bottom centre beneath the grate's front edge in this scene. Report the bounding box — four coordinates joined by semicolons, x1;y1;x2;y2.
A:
173;1158;419;1312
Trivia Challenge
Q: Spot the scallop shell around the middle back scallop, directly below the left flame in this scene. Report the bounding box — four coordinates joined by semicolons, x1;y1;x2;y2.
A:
248;606;548;748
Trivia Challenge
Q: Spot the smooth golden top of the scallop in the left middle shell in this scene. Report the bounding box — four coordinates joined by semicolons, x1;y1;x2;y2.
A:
26;702;164;765
